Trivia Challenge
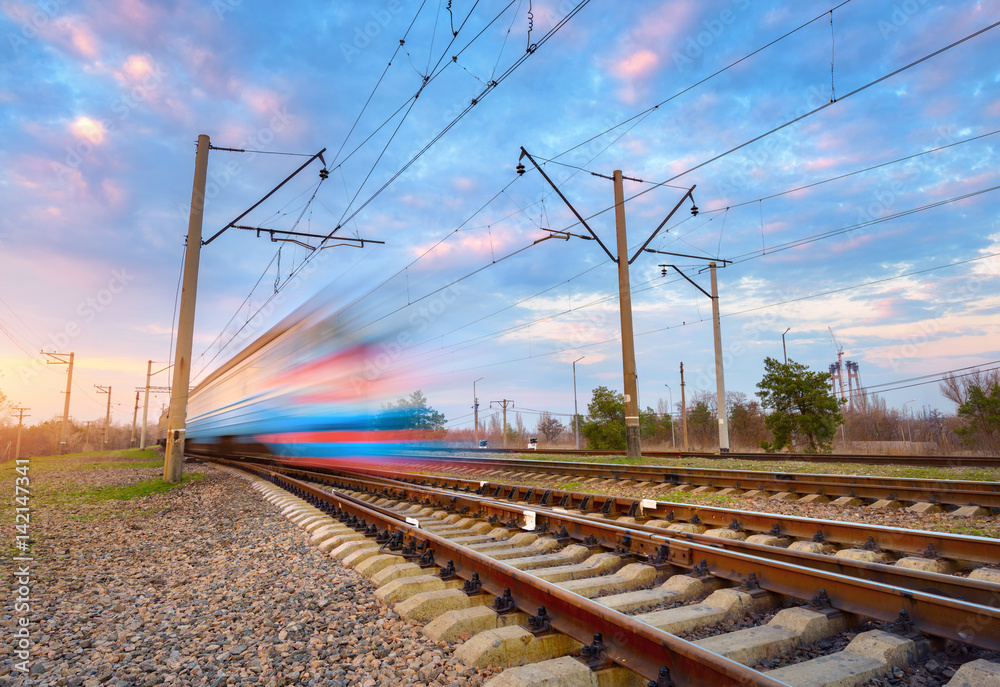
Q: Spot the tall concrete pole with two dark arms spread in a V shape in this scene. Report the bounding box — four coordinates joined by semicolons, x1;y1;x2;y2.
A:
517;147;698;458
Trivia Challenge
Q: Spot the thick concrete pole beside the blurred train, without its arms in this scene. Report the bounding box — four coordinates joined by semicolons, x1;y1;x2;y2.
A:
163;134;211;484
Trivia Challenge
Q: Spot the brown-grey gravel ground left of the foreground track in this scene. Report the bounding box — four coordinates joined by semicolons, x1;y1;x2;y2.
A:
0;456;498;687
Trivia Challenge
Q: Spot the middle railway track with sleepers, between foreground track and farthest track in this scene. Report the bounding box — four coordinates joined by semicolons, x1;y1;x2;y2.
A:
376;456;1000;515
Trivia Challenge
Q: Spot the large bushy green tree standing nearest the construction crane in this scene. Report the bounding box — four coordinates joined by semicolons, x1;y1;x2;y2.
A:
757;358;844;453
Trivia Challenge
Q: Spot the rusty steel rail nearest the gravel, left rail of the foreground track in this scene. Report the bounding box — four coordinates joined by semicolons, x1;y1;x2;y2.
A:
220;461;789;687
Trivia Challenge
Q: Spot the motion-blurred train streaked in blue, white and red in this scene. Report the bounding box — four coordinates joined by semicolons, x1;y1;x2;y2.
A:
161;296;435;465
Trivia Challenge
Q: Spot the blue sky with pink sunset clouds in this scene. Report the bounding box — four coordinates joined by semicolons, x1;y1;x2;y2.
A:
0;0;1000;436
